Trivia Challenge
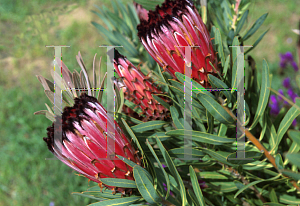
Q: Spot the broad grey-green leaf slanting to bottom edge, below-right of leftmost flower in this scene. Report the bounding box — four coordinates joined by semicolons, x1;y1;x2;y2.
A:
133;167;161;204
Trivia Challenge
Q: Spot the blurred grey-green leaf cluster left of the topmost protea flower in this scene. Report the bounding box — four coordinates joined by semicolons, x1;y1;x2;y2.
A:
92;0;157;68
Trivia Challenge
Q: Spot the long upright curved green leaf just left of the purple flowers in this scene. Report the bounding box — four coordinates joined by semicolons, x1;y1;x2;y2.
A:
249;59;271;130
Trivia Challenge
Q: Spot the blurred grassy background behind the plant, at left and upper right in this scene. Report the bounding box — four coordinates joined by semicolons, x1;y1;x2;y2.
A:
0;0;300;206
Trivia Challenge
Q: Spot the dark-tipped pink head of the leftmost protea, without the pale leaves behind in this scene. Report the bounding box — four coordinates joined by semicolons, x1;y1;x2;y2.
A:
44;93;141;194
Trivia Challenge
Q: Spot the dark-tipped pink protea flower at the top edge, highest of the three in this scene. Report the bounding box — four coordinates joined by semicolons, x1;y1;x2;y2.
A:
137;0;218;87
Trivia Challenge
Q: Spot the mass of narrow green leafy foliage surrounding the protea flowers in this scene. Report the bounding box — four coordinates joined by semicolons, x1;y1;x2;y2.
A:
24;0;300;206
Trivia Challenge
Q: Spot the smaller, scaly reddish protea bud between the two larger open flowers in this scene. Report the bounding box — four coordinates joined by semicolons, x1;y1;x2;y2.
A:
114;50;169;121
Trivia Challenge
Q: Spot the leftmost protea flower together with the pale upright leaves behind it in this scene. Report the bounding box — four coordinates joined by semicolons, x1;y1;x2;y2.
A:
35;53;141;194
